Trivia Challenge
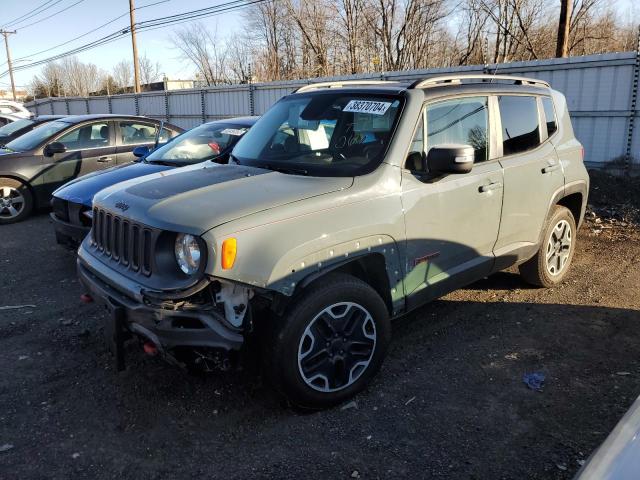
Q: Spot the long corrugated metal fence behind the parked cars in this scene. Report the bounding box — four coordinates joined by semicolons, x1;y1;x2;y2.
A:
27;52;640;169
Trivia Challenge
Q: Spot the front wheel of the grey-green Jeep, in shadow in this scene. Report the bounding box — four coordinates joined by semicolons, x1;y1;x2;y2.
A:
267;274;391;409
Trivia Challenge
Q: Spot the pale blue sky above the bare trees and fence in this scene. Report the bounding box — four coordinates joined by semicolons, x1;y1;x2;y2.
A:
0;0;636;89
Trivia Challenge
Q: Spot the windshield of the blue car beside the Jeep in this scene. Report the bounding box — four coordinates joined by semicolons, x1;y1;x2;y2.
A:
146;123;249;165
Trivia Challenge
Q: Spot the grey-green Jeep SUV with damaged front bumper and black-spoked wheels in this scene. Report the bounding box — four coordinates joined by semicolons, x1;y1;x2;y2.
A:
78;75;589;408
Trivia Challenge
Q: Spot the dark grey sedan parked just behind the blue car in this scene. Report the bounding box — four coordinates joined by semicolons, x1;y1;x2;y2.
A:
0;115;182;224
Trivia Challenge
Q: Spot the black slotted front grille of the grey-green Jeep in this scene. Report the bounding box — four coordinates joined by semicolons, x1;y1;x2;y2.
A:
91;207;158;277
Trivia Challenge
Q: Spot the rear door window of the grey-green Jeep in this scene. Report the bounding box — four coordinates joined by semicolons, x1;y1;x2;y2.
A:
498;95;540;155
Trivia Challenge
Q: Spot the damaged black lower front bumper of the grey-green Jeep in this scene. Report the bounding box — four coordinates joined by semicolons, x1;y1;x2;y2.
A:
78;260;244;370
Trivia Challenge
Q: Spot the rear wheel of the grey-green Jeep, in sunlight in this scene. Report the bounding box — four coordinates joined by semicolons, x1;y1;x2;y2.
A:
519;205;577;287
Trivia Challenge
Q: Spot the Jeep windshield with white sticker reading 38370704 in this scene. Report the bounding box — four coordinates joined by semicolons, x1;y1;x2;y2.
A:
233;93;402;177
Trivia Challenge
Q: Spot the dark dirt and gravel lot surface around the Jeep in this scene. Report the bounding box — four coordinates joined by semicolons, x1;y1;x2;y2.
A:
0;171;640;479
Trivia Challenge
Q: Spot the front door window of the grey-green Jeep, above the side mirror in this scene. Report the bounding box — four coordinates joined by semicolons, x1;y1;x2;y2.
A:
427;97;489;163
